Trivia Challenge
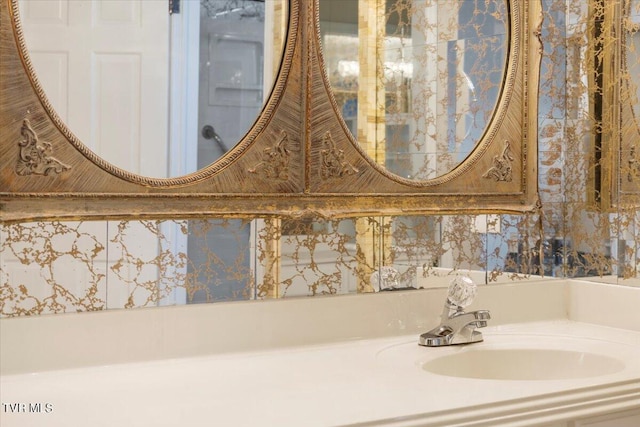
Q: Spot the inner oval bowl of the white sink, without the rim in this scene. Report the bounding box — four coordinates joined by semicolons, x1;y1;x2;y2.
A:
421;348;625;381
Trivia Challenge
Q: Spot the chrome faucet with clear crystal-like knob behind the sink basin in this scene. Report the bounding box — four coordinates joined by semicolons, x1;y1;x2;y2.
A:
418;276;491;347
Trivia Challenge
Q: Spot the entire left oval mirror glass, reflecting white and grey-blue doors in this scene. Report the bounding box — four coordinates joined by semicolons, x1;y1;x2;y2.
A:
19;0;287;178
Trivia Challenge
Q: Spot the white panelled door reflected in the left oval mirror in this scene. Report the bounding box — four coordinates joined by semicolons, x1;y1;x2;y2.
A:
20;0;169;177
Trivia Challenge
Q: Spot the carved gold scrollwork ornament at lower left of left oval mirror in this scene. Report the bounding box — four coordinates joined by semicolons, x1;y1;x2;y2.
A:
15;119;71;176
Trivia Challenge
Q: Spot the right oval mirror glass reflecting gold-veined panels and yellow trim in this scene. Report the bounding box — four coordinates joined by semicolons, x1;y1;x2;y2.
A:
320;0;509;181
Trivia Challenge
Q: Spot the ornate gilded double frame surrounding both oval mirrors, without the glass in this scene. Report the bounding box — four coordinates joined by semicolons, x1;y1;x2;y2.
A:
0;0;542;222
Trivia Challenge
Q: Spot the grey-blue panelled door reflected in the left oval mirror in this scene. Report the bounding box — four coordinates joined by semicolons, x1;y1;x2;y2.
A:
198;8;264;164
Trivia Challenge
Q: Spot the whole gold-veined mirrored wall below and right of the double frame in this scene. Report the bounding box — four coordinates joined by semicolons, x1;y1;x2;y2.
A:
0;0;640;317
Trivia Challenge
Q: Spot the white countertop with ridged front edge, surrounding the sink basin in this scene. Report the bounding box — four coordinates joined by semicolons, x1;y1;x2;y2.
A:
0;320;640;427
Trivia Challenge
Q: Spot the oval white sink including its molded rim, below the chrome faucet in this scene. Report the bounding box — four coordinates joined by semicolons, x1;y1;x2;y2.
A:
376;331;638;381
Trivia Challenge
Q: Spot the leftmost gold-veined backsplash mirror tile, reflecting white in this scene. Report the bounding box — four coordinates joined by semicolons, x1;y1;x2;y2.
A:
0;222;107;316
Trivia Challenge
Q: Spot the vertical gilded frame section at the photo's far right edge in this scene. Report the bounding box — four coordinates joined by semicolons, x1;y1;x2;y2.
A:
588;0;640;212
